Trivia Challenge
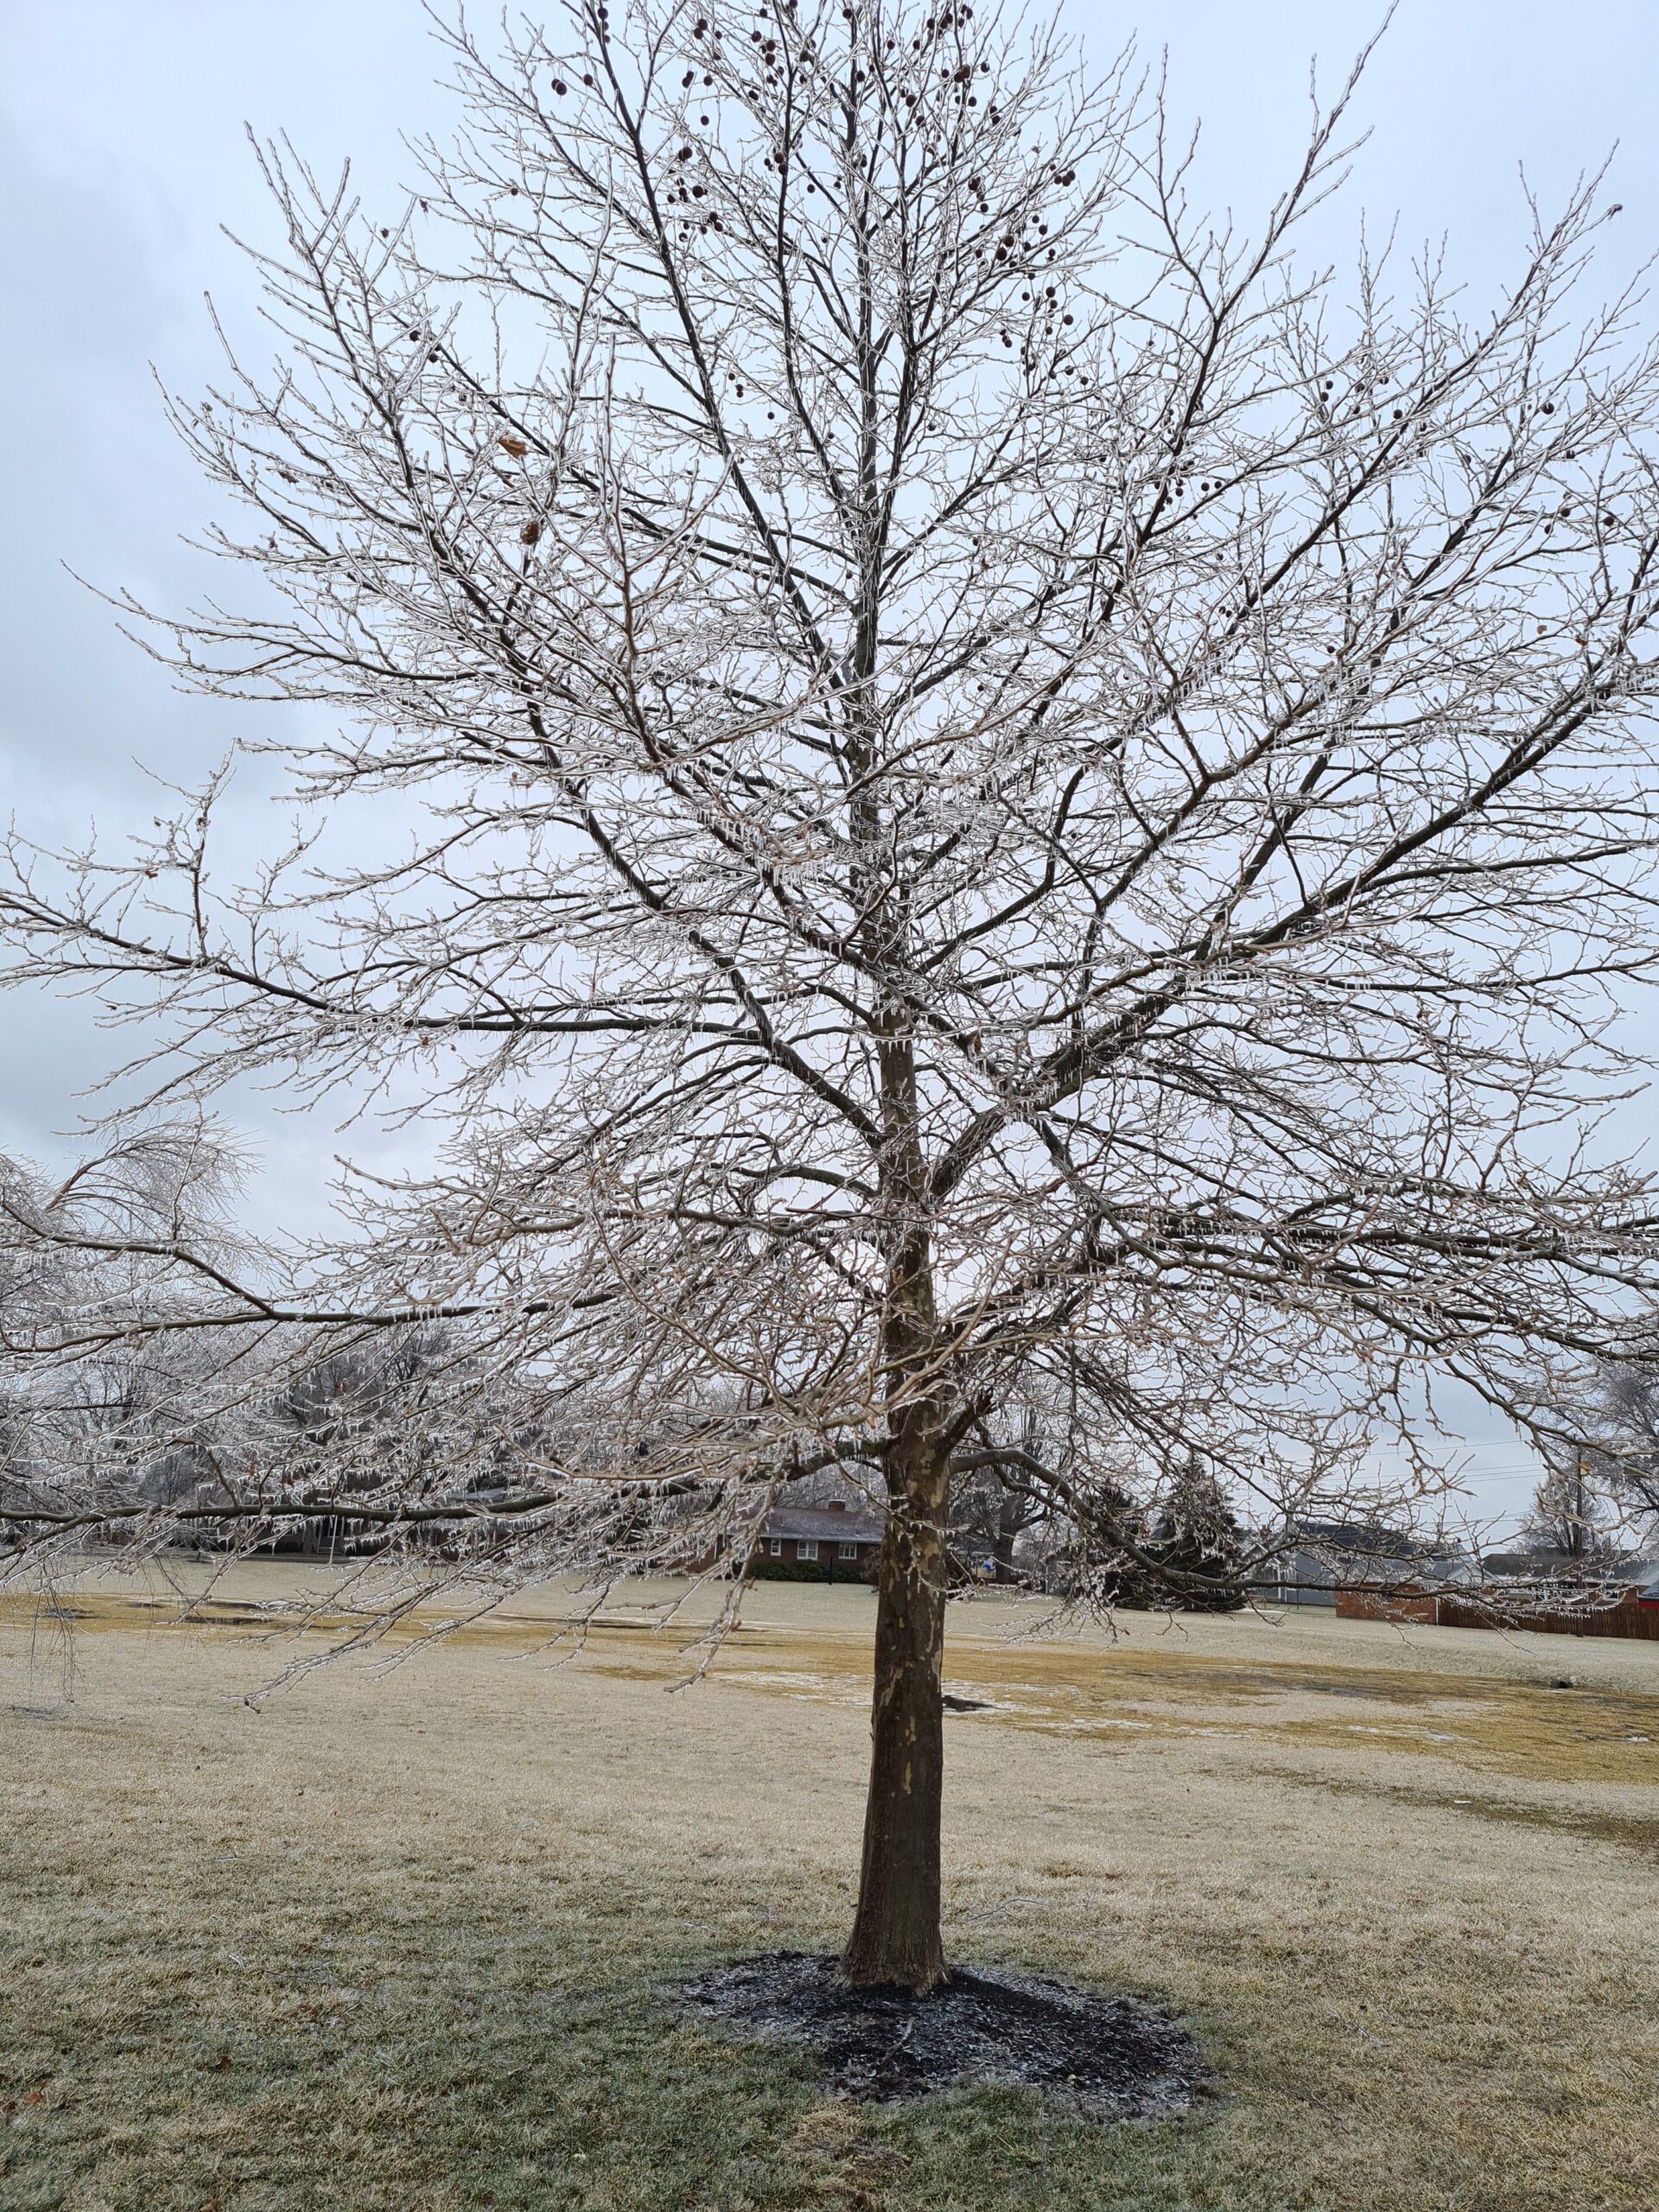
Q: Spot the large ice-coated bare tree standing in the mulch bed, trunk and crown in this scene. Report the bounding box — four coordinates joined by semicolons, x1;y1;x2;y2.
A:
3;0;1659;1988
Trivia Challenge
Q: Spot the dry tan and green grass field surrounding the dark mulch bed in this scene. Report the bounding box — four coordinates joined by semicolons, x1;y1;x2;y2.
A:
0;1566;1659;2212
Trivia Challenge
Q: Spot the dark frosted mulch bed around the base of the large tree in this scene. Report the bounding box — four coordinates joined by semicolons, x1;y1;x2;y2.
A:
675;1951;1210;2121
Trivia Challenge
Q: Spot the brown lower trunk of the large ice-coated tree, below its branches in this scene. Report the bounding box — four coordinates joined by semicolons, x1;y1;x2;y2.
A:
841;1438;949;1991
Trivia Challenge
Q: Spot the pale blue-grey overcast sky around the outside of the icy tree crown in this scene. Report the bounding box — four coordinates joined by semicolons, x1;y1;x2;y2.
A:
0;0;1659;1510
